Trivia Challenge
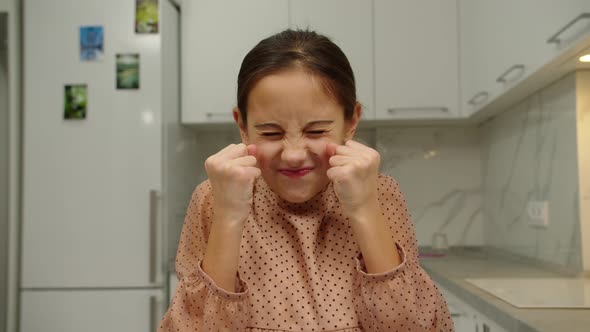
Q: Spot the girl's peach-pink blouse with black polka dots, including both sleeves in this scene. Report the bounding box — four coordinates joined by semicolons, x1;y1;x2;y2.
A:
159;175;454;332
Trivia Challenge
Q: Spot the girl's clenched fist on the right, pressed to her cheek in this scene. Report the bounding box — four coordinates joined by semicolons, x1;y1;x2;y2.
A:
326;140;381;217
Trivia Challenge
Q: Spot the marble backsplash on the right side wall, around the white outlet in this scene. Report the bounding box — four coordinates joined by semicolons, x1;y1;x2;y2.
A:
481;74;581;271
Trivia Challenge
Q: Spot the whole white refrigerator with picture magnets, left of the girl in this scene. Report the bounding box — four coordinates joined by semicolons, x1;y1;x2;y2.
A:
19;0;179;332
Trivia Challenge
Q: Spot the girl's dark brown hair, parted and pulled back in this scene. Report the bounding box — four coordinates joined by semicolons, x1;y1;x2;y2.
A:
238;29;356;124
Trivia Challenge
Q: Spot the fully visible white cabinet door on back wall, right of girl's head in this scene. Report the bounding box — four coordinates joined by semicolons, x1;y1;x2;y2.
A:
374;0;459;119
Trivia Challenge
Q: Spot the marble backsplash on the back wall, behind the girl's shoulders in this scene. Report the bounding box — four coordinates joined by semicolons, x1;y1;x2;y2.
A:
170;127;484;254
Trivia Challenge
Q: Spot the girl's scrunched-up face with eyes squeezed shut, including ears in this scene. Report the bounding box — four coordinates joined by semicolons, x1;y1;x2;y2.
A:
234;70;361;203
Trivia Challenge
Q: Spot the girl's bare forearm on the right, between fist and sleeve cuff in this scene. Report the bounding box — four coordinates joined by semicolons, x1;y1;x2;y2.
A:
349;202;402;273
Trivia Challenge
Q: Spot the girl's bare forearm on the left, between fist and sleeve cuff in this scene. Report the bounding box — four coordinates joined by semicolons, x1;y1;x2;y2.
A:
202;216;243;292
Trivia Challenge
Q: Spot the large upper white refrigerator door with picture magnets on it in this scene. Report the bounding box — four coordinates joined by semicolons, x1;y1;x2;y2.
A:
21;0;163;288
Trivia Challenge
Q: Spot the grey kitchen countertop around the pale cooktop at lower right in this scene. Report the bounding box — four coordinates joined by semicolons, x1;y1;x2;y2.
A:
420;247;590;332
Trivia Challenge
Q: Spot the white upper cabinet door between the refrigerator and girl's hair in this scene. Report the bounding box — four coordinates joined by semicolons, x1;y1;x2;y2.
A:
181;0;289;123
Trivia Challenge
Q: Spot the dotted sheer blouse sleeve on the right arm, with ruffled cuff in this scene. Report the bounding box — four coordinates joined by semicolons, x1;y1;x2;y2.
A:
354;176;454;332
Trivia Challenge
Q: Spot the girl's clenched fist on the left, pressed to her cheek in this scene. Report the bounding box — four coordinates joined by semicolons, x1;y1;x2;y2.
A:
205;143;261;223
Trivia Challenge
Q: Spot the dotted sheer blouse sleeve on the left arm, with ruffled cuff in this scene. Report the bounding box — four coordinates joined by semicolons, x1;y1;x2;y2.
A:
158;181;249;332
